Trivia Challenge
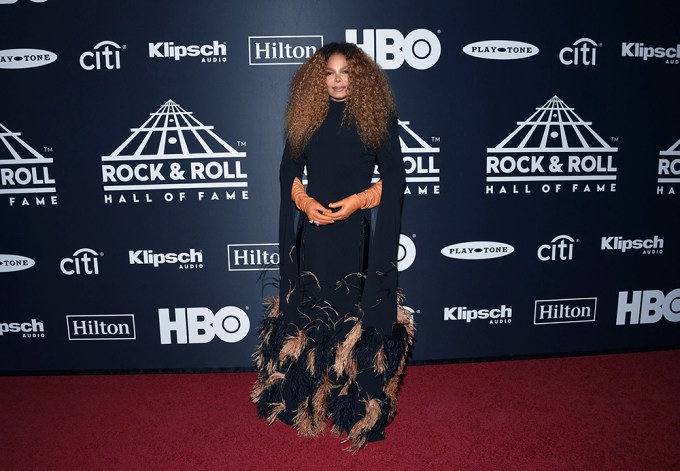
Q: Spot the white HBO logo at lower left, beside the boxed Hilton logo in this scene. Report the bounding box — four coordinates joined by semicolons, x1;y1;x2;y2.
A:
158;306;250;345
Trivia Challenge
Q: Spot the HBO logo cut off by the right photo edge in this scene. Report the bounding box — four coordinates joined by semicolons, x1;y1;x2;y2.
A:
616;288;680;325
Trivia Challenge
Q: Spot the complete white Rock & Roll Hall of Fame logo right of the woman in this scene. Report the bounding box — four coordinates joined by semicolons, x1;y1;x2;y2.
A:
486;96;617;195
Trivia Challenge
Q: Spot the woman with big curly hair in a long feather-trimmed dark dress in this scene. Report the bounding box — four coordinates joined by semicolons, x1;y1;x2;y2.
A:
251;43;414;451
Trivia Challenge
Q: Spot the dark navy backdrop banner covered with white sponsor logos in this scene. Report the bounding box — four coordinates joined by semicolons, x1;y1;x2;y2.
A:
0;0;680;373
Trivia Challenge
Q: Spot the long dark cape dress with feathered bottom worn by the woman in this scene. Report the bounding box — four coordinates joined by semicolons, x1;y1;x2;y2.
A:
251;101;414;451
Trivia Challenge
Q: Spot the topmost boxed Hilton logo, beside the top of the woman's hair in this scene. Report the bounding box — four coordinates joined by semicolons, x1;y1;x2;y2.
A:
248;35;323;65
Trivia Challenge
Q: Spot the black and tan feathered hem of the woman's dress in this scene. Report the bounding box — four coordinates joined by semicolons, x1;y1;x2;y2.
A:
251;298;415;451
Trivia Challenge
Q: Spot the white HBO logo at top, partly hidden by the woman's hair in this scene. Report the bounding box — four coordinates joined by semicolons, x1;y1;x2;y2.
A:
345;29;442;70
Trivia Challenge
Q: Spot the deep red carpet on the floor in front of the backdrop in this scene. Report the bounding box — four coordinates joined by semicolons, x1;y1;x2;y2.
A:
0;350;680;471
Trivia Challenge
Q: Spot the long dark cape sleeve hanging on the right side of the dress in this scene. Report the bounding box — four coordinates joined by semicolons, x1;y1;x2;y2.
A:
362;117;406;332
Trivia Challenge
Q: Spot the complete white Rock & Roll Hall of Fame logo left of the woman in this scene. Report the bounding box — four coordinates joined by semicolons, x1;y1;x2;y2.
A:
102;100;248;204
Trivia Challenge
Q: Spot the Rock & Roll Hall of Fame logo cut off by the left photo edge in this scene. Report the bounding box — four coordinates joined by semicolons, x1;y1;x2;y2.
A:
0;124;57;206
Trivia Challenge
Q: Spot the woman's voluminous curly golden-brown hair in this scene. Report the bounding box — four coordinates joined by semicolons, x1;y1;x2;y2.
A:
285;42;396;158
